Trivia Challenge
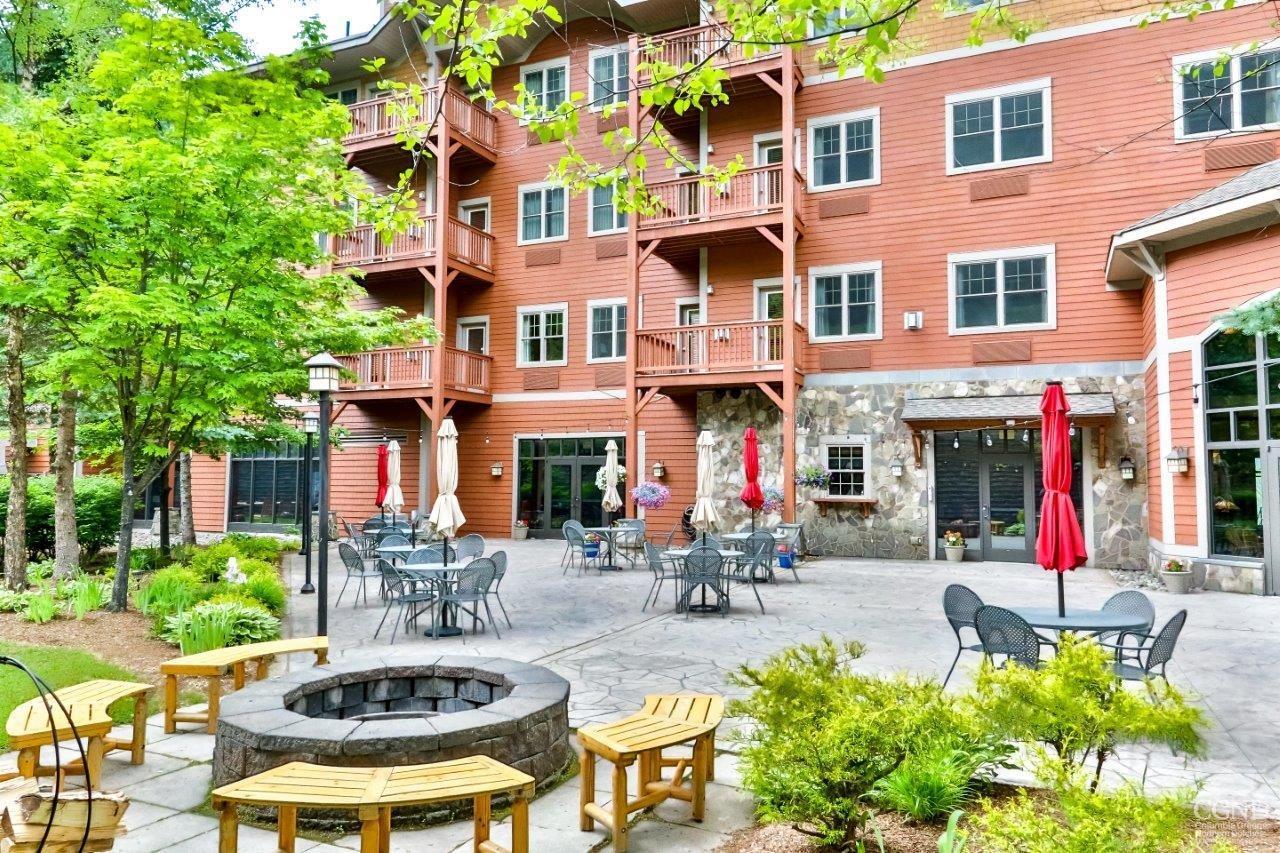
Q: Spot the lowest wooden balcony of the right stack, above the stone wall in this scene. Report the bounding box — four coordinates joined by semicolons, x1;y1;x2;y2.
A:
636;320;806;387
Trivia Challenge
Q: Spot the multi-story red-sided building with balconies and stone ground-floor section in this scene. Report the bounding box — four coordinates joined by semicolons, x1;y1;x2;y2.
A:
183;0;1280;593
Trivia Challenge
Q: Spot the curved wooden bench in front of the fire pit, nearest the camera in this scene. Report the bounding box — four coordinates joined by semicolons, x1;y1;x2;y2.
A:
212;756;534;853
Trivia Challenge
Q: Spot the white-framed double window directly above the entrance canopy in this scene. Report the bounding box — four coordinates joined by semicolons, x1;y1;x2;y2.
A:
947;245;1057;334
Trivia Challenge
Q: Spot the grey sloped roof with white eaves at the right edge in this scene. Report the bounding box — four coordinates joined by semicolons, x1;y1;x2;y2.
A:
1107;154;1280;288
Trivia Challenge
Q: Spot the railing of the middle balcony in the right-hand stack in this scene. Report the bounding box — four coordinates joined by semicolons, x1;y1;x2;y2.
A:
640;164;783;228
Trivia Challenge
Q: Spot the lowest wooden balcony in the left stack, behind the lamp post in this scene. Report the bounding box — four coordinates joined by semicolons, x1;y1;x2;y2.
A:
338;346;493;402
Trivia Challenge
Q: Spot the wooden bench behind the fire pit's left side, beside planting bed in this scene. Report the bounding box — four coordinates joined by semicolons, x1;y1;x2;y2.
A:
160;637;329;734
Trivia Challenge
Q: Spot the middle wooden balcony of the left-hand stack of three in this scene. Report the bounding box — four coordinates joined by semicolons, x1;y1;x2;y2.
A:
330;213;493;282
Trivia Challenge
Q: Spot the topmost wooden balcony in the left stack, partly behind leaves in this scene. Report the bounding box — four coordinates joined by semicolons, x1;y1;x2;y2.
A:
342;88;498;163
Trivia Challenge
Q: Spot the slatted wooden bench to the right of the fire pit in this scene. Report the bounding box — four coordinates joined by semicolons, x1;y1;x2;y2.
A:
577;695;724;853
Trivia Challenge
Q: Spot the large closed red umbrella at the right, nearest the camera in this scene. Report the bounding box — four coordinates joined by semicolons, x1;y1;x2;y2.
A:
1036;382;1088;616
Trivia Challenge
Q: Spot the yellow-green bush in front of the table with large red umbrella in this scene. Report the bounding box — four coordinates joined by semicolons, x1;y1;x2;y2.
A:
970;634;1204;780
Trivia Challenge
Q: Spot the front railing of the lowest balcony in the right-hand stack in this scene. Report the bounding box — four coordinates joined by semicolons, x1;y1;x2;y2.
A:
636;320;800;375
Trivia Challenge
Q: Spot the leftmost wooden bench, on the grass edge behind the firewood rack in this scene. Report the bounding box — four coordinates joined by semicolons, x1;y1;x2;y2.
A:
5;679;155;788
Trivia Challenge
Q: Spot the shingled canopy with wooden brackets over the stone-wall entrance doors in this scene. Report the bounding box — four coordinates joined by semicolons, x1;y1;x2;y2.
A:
902;393;1116;467
